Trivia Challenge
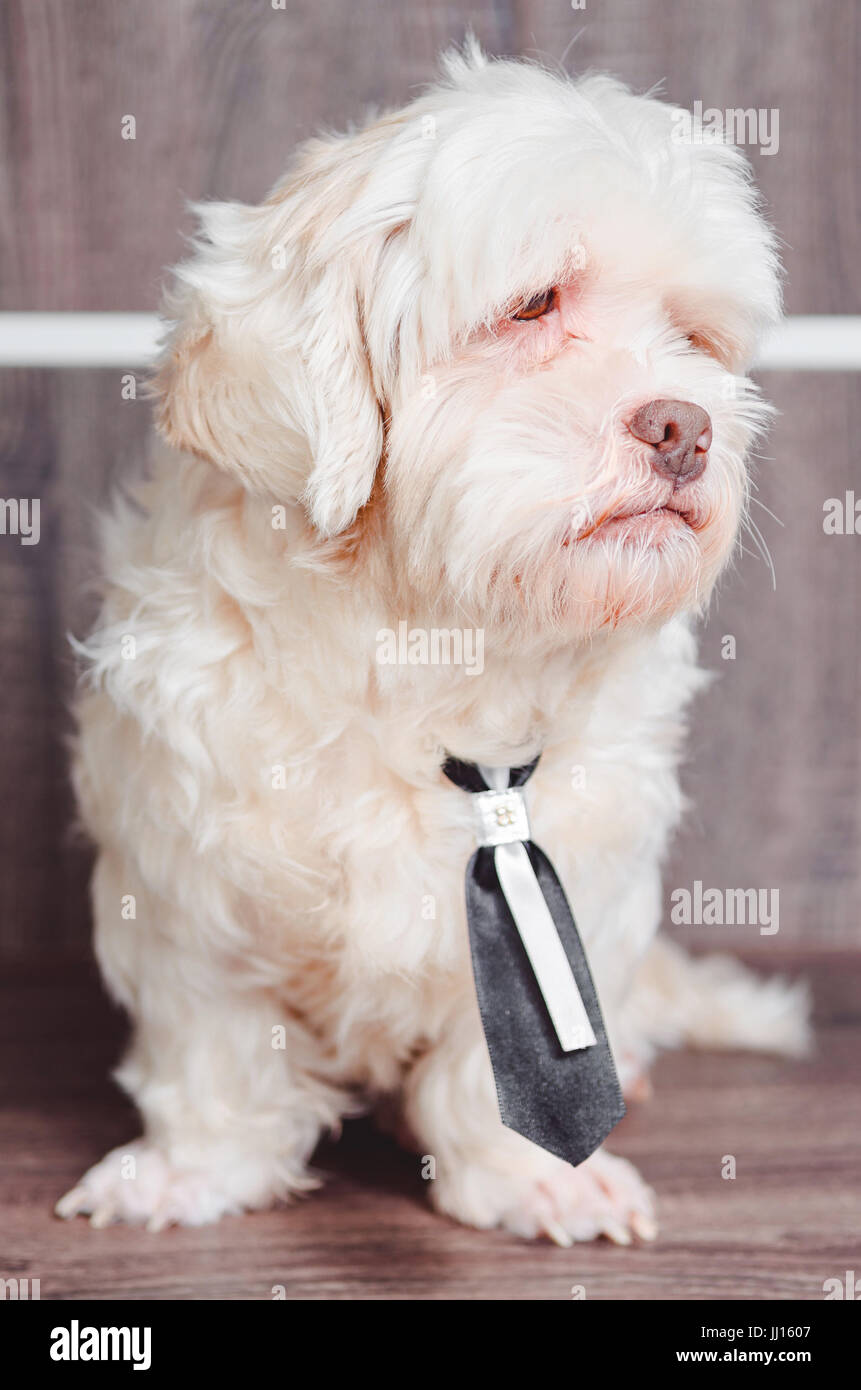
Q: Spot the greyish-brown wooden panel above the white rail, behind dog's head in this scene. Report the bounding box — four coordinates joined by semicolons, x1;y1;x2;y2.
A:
0;0;861;313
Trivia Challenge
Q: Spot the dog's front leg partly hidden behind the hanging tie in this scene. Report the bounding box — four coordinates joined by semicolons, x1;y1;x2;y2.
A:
405;999;657;1245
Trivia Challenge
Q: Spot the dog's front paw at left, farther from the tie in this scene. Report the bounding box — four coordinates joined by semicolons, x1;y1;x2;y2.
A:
54;1140;241;1232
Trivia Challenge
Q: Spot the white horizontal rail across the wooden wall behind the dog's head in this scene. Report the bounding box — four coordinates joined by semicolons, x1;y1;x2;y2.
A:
0;311;861;371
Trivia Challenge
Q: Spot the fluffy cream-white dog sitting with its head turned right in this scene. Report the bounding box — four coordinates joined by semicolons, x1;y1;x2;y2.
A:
58;44;807;1243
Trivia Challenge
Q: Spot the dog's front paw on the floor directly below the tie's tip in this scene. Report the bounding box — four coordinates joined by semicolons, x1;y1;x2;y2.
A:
434;1150;658;1245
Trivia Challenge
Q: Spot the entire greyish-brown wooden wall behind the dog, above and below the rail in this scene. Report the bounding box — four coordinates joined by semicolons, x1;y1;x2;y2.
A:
0;0;861;959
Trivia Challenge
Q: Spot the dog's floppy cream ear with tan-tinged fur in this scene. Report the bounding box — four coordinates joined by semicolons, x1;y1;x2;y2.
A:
153;132;395;535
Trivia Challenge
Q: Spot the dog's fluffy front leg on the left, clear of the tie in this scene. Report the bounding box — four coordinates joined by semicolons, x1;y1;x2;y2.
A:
57;855;342;1230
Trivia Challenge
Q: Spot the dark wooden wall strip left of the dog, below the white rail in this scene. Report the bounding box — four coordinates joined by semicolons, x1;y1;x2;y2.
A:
0;371;149;955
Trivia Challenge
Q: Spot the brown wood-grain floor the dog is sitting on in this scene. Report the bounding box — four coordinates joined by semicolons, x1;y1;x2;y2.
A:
0;951;861;1300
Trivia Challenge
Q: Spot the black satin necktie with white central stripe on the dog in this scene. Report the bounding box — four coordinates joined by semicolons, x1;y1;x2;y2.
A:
442;758;625;1163
